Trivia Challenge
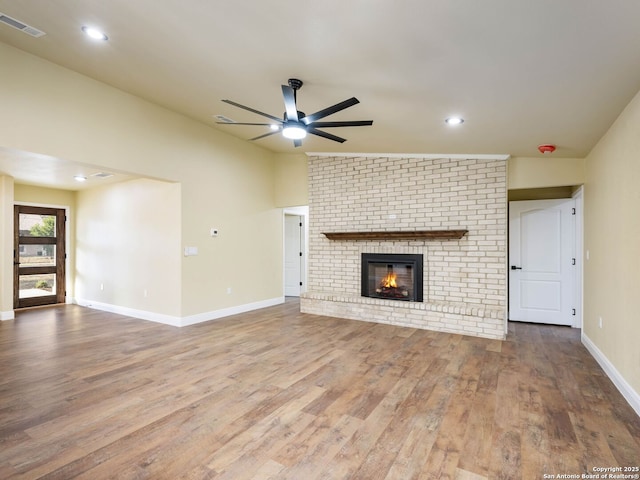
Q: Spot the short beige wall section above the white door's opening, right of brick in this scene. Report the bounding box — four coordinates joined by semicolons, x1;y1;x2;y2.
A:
508;155;585;190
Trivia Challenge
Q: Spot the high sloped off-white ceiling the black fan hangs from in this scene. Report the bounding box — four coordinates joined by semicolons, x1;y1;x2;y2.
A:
0;0;640;189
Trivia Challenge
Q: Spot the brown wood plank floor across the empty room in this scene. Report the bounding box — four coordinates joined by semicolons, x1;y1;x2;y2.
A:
0;301;640;480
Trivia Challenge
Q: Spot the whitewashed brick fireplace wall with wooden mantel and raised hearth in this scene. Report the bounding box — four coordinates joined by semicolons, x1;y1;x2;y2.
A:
300;155;507;339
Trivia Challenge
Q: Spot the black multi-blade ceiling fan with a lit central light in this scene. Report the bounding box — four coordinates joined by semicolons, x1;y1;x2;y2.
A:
216;78;373;147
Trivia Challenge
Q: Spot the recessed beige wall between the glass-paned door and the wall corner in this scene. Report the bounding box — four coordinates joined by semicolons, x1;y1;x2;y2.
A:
76;179;182;317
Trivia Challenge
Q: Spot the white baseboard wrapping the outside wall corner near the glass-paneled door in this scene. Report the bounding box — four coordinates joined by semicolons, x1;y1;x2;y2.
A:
76;297;284;327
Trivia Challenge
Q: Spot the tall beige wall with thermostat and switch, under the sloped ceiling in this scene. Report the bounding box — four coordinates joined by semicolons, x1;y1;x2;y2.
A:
0;43;283;316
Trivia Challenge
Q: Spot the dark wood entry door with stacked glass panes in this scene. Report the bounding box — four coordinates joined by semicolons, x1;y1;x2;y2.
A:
13;205;66;308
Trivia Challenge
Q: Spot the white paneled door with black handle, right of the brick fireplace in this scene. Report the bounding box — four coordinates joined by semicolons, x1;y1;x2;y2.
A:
509;199;576;325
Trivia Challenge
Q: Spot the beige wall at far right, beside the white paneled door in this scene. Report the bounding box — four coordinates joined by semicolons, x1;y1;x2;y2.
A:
584;88;640;395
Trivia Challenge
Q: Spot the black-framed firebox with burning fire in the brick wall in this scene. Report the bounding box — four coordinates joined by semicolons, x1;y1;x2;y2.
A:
361;253;422;302
